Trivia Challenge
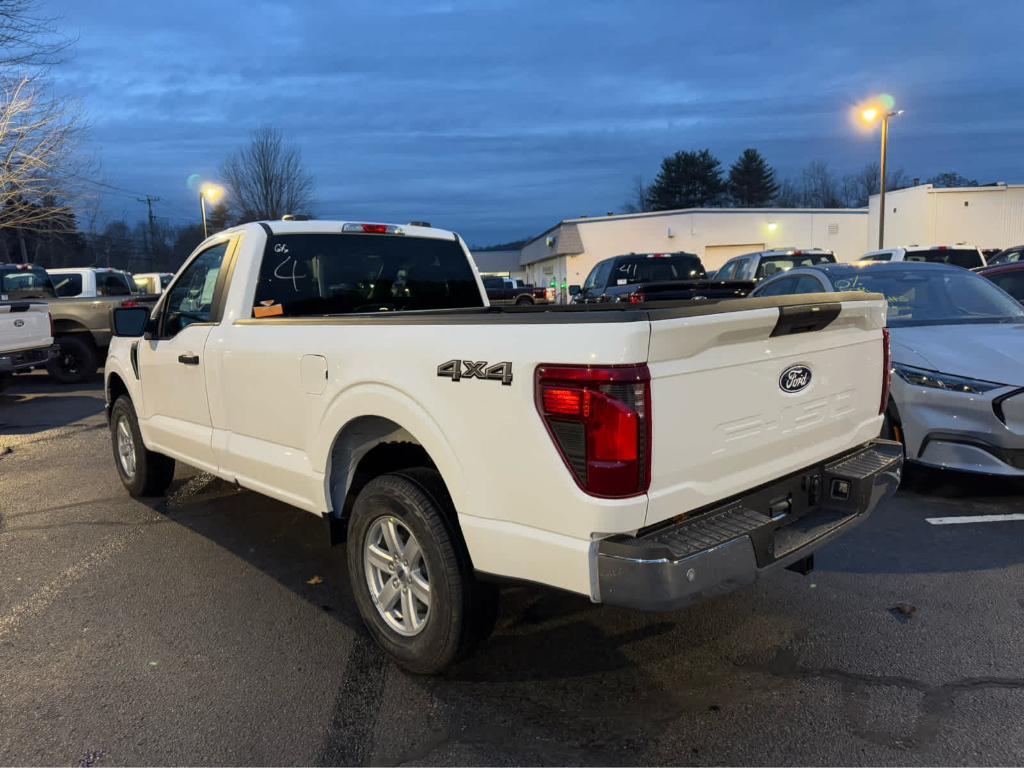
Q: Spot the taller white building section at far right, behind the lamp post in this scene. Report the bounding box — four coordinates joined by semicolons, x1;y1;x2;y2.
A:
868;184;1024;249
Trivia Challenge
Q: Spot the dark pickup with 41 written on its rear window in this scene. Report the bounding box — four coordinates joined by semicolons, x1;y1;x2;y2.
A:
569;251;755;304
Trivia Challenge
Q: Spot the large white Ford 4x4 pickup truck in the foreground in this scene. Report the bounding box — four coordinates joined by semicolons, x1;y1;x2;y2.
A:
105;221;902;672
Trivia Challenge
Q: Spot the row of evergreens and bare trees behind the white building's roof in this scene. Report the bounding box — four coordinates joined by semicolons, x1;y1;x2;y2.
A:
625;148;978;213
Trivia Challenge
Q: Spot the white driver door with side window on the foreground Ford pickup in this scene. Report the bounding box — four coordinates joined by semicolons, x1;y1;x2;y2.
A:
138;239;233;471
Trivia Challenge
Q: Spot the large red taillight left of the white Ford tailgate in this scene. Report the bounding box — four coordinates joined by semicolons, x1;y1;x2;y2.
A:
535;365;651;498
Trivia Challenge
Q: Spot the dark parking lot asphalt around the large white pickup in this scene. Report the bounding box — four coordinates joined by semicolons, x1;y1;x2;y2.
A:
6;375;1024;766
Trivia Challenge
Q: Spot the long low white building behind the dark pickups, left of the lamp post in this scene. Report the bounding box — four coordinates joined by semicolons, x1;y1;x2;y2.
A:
520;208;867;286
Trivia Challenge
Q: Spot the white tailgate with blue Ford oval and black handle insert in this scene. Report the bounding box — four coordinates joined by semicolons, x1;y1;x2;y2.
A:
646;294;886;525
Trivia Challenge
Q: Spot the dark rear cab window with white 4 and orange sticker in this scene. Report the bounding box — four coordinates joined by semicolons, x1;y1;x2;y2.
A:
253;232;483;317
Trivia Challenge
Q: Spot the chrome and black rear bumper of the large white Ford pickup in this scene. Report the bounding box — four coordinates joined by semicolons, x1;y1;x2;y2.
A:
596;440;903;610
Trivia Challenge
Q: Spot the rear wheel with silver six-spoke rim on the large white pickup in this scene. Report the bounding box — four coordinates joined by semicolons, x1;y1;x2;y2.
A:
347;469;497;674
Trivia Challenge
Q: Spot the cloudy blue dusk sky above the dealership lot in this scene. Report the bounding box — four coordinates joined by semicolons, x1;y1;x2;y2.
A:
50;0;1024;244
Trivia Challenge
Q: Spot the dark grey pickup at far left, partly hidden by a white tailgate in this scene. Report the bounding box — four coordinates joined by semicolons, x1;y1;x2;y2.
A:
0;264;157;384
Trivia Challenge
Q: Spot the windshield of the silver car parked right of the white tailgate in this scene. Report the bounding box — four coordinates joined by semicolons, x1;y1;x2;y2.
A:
833;267;1024;328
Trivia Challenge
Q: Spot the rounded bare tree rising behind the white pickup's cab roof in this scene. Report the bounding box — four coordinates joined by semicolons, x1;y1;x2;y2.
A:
220;126;313;222
